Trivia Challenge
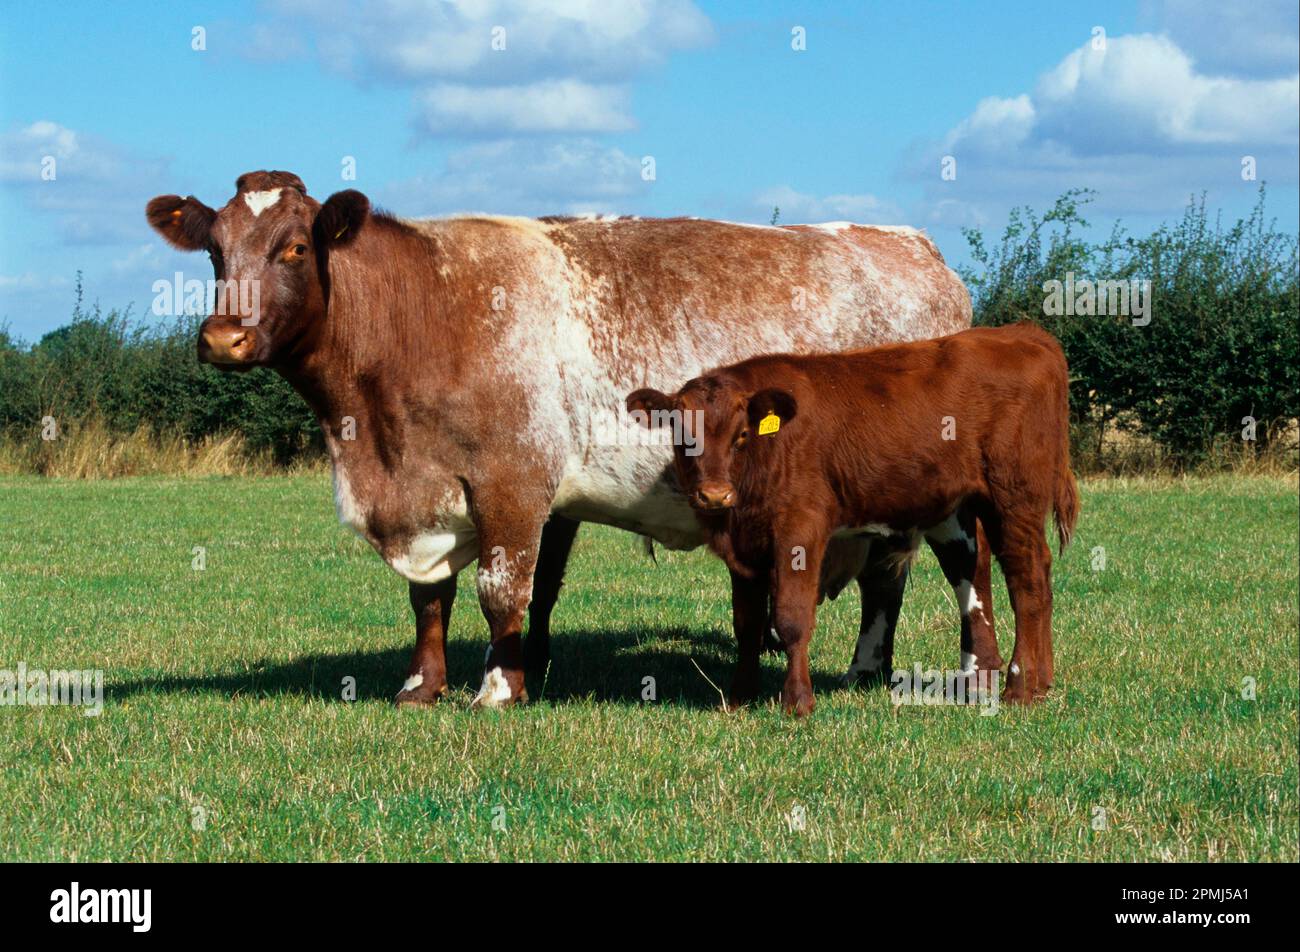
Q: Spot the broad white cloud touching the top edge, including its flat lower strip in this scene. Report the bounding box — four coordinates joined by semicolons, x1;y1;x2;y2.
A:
248;0;714;135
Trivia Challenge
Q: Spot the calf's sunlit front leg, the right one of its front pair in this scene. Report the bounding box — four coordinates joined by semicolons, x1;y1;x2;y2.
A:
772;519;827;717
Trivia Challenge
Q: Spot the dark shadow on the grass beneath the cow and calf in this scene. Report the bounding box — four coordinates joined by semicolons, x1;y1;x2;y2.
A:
105;628;837;707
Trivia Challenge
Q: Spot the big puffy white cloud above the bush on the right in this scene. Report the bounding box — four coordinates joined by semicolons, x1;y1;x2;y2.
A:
901;34;1300;226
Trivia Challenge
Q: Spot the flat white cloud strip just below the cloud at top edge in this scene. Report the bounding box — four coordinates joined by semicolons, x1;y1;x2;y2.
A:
420;79;633;135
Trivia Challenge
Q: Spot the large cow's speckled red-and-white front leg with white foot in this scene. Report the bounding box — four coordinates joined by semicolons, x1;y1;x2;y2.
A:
473;511;546;707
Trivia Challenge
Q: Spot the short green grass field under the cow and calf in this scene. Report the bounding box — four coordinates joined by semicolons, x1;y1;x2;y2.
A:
0;475;1300;861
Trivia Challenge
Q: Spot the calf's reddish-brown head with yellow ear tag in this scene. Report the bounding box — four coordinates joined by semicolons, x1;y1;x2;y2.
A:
627;373;796;511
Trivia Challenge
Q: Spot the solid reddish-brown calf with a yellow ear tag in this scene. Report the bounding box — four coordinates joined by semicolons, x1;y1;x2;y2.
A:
627;324;1079;715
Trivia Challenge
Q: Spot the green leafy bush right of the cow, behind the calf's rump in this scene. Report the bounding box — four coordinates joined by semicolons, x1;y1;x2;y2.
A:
962;186;1300;467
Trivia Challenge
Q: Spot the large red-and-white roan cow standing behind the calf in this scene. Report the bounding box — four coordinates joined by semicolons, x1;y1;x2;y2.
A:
146;172;1001;707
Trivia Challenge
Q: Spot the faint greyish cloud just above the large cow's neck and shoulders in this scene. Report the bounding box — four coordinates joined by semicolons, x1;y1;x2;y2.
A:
380;139;649;215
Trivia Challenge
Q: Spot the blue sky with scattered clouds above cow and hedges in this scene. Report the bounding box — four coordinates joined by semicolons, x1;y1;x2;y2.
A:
0;0;1300;339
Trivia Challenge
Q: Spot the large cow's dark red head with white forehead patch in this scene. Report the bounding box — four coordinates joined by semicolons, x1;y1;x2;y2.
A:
144;172;371;369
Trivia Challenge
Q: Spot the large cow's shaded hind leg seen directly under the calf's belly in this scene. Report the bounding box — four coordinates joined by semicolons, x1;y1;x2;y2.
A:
840;536;913;687
